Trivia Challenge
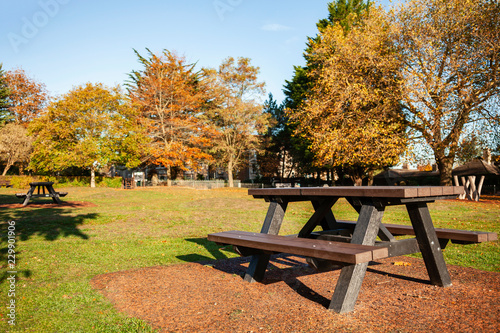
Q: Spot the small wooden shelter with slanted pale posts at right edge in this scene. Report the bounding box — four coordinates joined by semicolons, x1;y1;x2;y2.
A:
452;159;500;201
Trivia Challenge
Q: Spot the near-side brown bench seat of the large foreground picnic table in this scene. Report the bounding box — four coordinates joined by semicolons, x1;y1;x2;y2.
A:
208;230;388;264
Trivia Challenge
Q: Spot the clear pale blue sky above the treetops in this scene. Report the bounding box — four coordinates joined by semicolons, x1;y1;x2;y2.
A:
0;0;388;101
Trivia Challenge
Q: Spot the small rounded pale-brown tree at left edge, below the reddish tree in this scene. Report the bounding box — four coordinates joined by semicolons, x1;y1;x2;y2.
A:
0;123;33;176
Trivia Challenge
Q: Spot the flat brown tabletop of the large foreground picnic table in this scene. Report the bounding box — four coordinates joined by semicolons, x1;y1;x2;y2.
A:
248;186;464;198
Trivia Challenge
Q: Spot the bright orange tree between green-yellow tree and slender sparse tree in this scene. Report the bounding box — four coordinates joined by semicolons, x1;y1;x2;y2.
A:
129;50;211;180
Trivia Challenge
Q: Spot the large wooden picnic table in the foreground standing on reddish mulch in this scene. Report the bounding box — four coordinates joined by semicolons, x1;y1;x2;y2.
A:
208;186;497;313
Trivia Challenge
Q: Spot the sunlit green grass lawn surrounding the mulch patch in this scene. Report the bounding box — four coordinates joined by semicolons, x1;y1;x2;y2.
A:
0;187;500;332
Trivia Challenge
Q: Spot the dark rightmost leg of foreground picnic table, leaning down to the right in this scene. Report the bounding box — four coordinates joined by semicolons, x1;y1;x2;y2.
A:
406;202;451;287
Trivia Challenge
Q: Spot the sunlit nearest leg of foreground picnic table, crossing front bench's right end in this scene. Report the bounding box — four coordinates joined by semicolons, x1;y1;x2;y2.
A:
329;202;384;313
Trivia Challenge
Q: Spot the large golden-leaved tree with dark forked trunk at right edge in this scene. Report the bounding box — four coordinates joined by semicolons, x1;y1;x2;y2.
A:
394;0;500;185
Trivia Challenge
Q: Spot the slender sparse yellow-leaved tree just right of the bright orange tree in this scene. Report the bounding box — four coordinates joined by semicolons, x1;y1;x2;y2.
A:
206;57;267;187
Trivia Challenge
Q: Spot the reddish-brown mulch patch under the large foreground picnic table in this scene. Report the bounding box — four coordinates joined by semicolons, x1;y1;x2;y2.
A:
92;255;500;332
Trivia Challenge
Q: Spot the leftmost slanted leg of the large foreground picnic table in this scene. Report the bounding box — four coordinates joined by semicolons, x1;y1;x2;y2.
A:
244;201;288;282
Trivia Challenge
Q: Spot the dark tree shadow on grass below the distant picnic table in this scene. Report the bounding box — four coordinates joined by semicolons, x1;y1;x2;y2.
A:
0;200;99;283
